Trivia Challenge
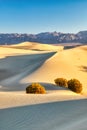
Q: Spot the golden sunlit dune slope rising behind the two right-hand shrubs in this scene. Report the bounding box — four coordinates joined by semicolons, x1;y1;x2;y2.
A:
23;46;87;93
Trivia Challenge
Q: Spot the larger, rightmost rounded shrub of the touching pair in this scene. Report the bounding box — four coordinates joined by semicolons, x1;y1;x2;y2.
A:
68;79;82;93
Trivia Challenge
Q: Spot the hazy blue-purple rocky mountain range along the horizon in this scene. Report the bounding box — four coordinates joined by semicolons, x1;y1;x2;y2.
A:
0;31;87;45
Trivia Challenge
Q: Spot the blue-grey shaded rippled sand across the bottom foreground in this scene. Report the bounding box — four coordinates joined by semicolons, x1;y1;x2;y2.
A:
0;100;87;130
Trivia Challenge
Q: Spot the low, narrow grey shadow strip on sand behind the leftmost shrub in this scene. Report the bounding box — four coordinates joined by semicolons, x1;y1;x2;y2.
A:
0;82;69;92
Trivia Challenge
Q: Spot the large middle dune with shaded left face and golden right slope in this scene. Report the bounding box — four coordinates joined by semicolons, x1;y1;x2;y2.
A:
0;43;87;99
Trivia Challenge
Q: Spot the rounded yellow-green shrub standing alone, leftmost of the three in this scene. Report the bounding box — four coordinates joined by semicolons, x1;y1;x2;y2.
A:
26;83;46;94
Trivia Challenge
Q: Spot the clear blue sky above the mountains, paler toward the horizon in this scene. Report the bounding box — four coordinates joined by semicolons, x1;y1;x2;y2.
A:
0;0;87;34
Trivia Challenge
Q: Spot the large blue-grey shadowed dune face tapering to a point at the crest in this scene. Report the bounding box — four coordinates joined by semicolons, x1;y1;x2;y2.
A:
0;52;56;91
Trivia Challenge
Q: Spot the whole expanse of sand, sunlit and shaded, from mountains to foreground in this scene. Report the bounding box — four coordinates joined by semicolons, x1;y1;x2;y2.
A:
0;43;87;130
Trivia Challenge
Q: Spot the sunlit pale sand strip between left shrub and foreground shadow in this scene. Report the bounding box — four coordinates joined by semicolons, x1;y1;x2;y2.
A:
0;87;86;109
